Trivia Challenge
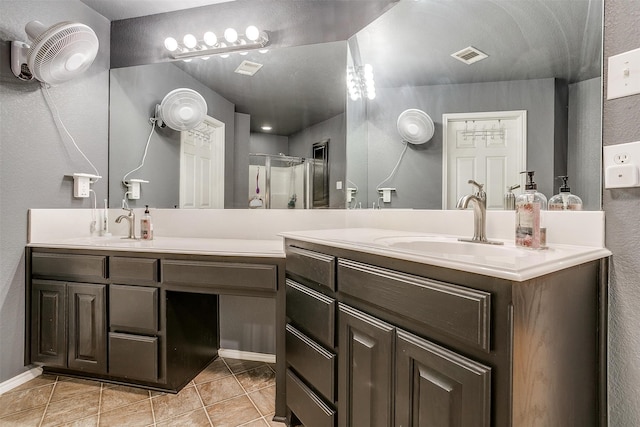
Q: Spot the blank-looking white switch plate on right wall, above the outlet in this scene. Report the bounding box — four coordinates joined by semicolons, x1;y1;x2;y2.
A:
607;48;640;99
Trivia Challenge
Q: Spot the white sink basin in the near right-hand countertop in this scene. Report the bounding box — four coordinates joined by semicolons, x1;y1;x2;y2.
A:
375;236;531;258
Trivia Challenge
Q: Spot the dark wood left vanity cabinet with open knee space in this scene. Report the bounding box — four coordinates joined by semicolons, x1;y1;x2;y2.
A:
25;247;285;406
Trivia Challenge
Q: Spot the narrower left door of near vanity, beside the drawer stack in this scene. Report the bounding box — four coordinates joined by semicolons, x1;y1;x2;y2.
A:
338;303;394;427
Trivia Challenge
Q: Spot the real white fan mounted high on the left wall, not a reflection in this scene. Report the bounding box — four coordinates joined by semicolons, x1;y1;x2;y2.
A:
11;21;99;85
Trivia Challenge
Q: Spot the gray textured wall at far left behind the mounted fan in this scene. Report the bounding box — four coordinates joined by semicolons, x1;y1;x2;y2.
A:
0;0;110;383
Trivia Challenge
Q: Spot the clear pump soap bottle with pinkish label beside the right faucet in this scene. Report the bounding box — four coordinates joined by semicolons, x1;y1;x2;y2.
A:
516;171;547;249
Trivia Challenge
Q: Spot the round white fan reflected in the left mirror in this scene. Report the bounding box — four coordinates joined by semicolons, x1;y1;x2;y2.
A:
151;88;207;131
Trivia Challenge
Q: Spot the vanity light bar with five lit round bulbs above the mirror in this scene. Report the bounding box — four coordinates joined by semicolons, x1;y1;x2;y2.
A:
164;25;269;59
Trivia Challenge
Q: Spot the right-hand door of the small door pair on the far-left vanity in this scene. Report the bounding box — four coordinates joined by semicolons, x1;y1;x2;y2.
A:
68;283;107;373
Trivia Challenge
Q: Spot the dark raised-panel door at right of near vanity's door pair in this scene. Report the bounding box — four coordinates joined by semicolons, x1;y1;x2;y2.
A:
395;330;491;427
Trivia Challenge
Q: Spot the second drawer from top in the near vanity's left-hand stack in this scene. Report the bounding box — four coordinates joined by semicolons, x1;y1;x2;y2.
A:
286;279;336;348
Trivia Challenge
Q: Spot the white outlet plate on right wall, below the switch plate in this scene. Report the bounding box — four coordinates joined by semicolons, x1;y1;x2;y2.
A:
603;141;640;188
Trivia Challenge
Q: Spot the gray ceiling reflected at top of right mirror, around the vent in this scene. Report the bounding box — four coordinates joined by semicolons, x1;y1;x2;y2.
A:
356;0;602;87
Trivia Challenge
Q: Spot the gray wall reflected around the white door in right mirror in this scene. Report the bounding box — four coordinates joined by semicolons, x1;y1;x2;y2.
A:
362;79;566;209
